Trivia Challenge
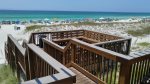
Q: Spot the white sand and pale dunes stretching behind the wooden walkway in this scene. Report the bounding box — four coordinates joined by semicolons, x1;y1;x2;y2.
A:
0;22;150;64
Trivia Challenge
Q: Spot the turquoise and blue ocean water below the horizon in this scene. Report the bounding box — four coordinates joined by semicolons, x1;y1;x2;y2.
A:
0;10;150;21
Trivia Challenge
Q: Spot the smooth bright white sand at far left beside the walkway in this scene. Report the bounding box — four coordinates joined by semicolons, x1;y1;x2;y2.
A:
0;25;26;64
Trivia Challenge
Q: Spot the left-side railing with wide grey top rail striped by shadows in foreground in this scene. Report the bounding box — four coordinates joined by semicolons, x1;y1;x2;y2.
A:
6;34;76;84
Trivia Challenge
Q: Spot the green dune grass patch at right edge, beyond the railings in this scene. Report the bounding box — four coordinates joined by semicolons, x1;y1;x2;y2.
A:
127;26;150;36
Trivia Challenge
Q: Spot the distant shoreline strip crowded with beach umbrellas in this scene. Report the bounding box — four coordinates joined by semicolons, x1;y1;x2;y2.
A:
0;16;150;25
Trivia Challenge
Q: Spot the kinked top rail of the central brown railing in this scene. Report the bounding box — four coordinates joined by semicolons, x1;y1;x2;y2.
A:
43;35;132;61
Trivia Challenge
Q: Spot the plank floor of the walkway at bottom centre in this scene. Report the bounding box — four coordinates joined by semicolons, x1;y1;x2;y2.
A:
69;67;96;84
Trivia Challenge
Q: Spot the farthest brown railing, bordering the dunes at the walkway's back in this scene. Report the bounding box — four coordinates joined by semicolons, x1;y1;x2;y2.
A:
29;30;123;45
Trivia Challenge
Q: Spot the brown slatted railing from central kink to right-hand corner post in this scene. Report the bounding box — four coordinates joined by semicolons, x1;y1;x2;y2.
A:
43;39;150;84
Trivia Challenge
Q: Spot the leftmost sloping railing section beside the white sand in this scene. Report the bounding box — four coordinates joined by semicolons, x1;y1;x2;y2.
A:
5;35;26;73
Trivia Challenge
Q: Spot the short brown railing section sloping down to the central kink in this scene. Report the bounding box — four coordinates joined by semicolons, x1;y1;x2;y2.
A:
43;39;71;65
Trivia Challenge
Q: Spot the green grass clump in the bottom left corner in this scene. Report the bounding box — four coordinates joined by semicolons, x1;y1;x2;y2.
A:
0;64;18;84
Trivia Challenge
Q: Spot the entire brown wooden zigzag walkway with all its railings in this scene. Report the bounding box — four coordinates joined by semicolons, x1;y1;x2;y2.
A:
5;30;150;84
